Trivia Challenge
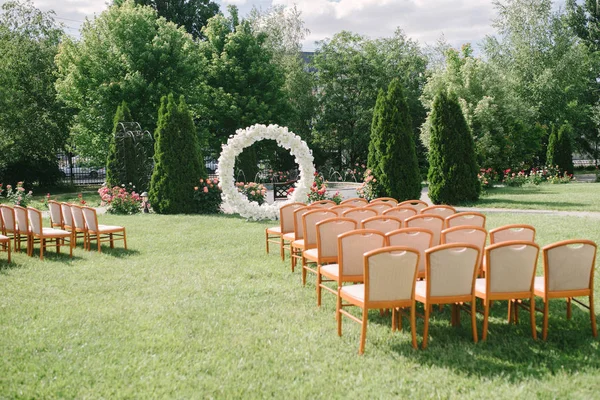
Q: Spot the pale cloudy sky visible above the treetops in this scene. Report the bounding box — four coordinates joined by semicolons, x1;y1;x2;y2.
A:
0;0;564;51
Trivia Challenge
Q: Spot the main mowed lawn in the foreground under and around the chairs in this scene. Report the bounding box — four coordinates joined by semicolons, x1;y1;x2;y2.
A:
0;212;600;399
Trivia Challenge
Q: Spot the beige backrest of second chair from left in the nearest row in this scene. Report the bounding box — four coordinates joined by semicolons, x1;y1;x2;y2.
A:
425;243;479;297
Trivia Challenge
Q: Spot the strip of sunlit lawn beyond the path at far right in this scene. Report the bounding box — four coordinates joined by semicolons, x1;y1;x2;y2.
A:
469;183;600;211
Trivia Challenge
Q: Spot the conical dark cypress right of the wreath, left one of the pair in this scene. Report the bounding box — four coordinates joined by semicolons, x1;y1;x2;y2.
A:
367;79;421;201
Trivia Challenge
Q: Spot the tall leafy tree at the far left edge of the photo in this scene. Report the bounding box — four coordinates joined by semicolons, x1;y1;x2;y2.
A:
0;1;71;185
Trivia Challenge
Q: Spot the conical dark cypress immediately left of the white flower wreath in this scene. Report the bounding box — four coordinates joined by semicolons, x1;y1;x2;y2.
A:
149;94;206;214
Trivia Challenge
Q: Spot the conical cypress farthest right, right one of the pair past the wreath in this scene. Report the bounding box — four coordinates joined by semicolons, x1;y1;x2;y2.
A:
428;91;481;204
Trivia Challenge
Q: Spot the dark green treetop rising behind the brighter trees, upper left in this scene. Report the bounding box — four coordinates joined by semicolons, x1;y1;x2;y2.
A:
114;0;219;39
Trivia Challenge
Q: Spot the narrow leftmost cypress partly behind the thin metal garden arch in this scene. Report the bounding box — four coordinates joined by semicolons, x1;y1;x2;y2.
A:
106;101;135;187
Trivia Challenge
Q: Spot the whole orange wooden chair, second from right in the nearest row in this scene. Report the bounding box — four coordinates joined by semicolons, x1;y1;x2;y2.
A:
475;240;540;340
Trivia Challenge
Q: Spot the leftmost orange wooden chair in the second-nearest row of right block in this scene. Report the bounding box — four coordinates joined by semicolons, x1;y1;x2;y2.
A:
317;229;385;307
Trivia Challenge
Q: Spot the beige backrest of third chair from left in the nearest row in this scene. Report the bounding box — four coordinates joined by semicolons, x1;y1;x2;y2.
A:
485;240;540;293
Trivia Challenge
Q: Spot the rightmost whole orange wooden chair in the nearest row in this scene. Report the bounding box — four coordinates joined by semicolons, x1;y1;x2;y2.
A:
534;239;598;340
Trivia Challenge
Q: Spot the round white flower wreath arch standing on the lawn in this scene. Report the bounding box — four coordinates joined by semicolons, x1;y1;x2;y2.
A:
217;124;315;220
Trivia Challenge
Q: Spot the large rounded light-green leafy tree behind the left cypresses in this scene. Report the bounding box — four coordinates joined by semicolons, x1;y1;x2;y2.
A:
56;0;206;164
